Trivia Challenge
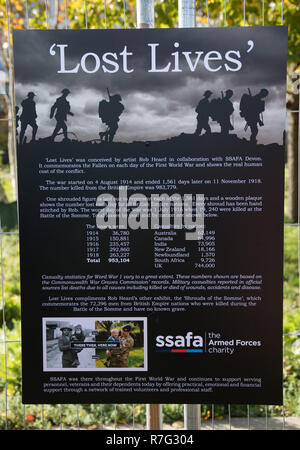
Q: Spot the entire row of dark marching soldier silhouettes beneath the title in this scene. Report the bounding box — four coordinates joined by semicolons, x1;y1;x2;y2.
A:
16;88;268;145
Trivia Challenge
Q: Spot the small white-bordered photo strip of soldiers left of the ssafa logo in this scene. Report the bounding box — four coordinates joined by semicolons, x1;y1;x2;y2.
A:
43;317;147;372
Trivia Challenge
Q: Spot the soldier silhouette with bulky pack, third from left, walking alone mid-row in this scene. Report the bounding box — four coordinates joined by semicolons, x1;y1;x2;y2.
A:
98;89;124;142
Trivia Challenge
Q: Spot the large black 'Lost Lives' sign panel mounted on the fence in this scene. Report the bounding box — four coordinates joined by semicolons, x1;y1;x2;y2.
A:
14;27;287;404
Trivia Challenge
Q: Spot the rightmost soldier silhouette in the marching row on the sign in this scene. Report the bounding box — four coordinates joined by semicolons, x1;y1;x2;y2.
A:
240;89;269;144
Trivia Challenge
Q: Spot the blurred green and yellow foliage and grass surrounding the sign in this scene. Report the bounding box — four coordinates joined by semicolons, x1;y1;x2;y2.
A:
0;0;300;429
